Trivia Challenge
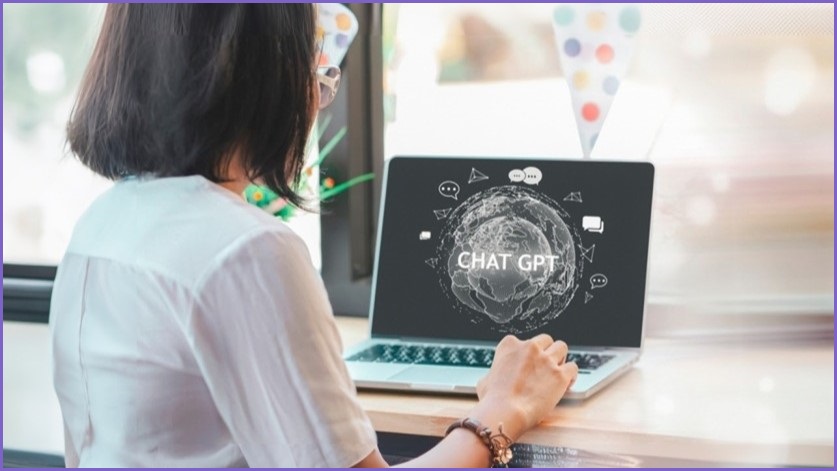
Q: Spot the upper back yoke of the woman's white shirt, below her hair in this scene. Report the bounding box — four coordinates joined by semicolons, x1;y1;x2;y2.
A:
68;177;305;285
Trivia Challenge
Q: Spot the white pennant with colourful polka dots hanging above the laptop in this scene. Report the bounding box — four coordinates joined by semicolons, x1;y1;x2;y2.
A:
552;3;642;157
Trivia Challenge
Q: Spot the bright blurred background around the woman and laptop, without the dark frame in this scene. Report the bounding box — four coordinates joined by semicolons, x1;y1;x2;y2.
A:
3;0;834;453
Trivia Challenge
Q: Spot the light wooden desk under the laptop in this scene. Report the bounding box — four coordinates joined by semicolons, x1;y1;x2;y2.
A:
337;318;834;467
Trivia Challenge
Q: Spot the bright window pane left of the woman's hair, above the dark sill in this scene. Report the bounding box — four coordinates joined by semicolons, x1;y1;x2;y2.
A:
3;4;324;268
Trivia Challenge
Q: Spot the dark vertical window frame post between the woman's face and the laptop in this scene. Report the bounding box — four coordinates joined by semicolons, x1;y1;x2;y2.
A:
320;4;384;317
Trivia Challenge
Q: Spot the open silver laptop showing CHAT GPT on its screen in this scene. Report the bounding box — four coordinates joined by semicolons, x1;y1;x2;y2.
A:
344;157;654;399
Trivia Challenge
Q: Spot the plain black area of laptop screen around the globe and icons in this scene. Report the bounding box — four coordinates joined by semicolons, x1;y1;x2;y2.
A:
372;157;654;347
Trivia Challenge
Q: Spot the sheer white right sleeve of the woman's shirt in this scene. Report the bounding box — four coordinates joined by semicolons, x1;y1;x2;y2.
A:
191;230;375;468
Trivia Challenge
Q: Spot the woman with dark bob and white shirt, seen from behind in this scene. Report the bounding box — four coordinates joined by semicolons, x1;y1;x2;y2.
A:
50;4;577;467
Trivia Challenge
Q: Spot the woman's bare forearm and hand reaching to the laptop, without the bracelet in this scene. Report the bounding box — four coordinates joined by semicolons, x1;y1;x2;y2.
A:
355;334;578;468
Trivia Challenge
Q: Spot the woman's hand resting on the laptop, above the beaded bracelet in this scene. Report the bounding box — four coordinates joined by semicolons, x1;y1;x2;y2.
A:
471;334;578;440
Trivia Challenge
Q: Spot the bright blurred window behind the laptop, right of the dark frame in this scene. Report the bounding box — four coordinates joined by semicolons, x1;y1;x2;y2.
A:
383;4;834;320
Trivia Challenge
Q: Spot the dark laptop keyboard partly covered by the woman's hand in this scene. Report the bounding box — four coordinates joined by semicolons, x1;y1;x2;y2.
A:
348;344;613;371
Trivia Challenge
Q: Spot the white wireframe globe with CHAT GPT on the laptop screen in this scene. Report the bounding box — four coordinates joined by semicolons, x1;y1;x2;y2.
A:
438;185;583;333
